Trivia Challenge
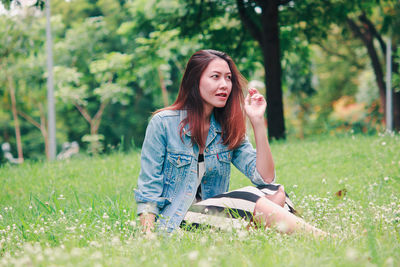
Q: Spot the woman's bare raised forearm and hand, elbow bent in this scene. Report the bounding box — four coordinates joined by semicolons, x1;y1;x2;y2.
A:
244;88;275;183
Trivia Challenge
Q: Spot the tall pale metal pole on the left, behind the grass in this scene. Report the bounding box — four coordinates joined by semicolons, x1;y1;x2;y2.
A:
46;0;56;160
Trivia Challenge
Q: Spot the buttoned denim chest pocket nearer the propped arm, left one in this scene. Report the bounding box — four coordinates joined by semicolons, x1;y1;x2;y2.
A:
165;153;192;186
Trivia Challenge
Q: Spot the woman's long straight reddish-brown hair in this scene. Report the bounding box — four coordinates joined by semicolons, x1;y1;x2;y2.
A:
157;50;247;149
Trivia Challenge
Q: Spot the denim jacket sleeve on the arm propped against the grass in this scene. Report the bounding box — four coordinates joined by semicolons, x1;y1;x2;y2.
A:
135;115;167;215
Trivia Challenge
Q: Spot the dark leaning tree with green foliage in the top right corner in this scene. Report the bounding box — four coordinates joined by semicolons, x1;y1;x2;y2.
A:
282;0;400;129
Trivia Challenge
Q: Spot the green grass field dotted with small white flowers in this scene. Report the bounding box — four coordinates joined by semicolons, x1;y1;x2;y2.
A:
0;135;400;266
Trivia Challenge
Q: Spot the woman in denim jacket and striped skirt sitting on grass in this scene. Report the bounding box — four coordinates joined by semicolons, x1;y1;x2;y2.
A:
135;50;325;238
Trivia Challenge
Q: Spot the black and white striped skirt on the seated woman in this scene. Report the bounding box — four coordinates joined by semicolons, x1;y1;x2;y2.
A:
181;184;295;228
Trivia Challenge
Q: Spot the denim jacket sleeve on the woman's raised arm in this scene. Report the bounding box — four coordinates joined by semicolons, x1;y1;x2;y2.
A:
232;136;276;185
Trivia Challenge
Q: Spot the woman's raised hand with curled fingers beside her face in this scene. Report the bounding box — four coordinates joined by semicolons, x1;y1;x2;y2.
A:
244;88;267;123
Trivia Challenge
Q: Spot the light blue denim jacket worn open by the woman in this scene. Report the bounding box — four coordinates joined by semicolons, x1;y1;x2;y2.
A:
135;110;276;232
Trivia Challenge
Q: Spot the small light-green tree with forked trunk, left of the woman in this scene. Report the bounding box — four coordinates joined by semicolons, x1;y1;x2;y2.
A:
55;52;132;154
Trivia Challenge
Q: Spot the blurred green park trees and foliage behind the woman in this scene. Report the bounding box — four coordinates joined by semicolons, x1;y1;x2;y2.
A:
0;0;400;163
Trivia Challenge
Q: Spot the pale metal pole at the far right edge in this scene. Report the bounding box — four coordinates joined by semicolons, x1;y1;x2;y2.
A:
386;37;393;132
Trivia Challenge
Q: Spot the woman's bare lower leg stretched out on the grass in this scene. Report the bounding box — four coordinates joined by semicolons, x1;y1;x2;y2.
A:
255;198;328;237
